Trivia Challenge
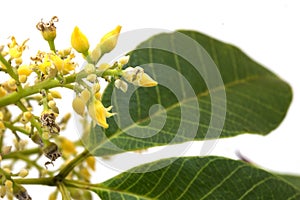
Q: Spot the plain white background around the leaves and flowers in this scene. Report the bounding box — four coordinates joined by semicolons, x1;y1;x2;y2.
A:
0;0;300;199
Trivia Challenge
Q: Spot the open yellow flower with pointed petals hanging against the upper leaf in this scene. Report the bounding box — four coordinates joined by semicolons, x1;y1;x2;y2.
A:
88;99;114;128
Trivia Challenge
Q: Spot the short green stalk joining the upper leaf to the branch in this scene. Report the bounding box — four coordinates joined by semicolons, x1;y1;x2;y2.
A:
55;150;90;181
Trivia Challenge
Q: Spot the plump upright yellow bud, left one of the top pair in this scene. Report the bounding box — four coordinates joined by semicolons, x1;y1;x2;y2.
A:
71;26;90;55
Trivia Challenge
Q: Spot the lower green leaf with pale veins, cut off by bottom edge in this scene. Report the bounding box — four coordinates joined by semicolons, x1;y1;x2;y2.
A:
93;156;300;200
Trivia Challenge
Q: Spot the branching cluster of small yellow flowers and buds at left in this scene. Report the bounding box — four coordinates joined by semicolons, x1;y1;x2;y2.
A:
0;17;157;200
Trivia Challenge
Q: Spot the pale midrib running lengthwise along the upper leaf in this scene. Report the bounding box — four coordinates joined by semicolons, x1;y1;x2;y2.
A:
92;74;274;152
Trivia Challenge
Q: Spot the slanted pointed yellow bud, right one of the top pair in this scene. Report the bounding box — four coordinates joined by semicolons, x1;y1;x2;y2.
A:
100;26;122;53
